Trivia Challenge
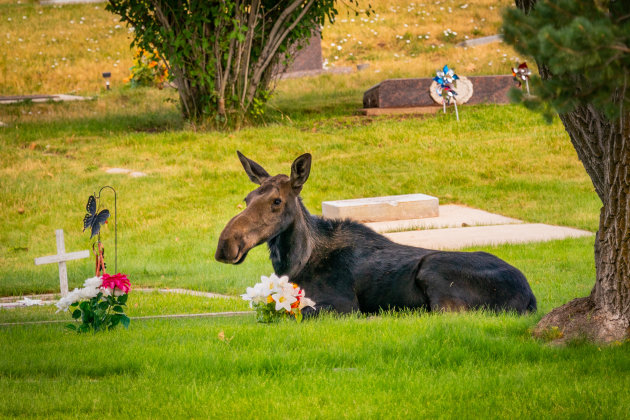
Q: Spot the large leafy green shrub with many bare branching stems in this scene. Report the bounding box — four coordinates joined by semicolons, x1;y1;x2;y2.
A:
106;0;370;126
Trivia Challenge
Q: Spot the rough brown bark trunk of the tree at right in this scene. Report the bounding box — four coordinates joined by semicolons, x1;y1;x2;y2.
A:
515;0;630;342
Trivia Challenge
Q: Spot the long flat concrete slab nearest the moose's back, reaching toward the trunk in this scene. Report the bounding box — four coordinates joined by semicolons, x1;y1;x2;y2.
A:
385;223;593;249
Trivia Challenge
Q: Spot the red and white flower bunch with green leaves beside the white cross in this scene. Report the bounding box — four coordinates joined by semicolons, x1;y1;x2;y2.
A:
56;273;131;333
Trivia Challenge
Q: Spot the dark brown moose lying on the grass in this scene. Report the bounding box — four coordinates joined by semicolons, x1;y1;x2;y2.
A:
215;151;536;316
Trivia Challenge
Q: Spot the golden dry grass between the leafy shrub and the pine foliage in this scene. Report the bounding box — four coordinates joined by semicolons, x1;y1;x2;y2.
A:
322;0;524;77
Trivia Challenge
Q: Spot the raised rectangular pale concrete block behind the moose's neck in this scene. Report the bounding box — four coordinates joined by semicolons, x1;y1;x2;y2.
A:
322;194;439;222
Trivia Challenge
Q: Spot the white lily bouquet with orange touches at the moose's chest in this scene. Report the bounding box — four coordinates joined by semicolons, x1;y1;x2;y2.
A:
241;274;315;323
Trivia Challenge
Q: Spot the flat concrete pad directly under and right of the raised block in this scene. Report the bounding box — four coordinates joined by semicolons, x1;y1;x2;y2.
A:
365;204;523;233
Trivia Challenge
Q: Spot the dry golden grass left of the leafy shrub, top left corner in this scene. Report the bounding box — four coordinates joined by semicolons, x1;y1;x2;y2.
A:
0;0;133;95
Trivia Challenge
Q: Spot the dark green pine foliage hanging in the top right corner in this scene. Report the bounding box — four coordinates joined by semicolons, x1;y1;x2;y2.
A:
503;0;630;119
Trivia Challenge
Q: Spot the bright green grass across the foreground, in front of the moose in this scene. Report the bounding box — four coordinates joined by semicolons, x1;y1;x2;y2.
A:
0;313;630;419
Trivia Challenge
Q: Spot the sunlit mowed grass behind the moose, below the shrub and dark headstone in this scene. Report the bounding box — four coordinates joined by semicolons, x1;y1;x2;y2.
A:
0;94;600;295
